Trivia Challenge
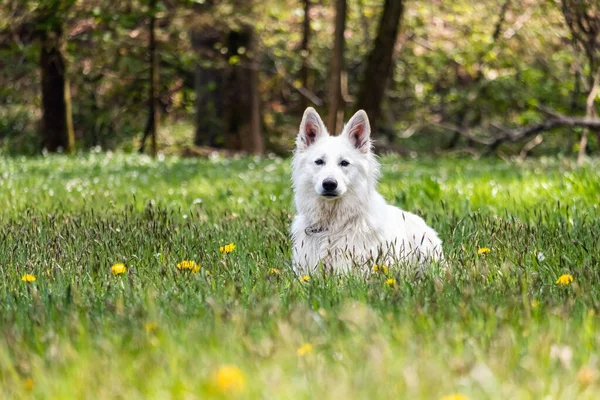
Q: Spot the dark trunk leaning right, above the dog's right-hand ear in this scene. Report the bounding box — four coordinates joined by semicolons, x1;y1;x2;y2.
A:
357;0;404;132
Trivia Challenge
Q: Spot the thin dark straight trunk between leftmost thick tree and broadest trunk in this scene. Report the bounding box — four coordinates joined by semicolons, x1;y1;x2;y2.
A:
140;0;158;157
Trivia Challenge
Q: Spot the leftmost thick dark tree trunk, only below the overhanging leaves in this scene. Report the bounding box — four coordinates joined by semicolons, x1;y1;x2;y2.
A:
40;28;75;153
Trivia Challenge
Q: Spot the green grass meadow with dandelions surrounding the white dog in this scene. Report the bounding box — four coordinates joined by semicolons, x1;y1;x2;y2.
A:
0;154;600;399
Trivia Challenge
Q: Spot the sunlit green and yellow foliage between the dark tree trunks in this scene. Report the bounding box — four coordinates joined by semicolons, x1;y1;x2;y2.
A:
0;0;588;152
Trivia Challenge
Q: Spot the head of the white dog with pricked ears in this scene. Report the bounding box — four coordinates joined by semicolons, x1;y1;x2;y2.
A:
293;107;378;200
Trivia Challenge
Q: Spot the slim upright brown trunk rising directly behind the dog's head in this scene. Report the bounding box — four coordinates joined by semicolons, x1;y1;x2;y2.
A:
327;0;347;135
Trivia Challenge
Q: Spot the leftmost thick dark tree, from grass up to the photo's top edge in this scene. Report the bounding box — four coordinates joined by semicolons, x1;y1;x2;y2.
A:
37;0;75;153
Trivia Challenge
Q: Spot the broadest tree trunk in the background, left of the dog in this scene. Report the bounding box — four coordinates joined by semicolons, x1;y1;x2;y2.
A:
192;1;264;154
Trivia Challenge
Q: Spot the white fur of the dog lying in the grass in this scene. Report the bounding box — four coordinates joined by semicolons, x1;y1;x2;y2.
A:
291;107;443;274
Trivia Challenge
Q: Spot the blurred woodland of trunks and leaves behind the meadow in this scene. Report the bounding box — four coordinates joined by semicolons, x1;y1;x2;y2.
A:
0;0;600;160
